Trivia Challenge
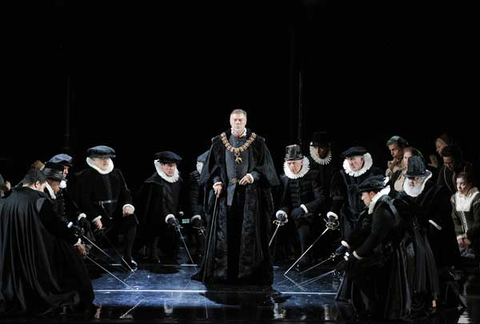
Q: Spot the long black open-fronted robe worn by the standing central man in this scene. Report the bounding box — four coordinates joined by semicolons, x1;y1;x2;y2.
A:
193;130;279;284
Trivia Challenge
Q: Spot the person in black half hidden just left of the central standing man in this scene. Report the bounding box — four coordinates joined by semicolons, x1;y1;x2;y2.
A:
187;151;208;262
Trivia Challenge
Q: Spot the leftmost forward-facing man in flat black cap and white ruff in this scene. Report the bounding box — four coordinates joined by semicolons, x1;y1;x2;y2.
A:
74;145;138;269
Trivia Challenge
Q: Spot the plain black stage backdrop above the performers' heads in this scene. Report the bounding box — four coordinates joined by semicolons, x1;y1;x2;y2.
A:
0;0;479;188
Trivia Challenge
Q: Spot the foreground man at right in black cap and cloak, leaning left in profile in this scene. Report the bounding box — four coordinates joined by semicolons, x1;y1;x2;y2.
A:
337;175;411;320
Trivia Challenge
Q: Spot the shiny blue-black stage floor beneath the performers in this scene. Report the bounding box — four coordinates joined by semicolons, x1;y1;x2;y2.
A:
2;247;480;323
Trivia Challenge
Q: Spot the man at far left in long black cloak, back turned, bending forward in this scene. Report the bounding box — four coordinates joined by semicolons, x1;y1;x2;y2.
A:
0;169;94;316
